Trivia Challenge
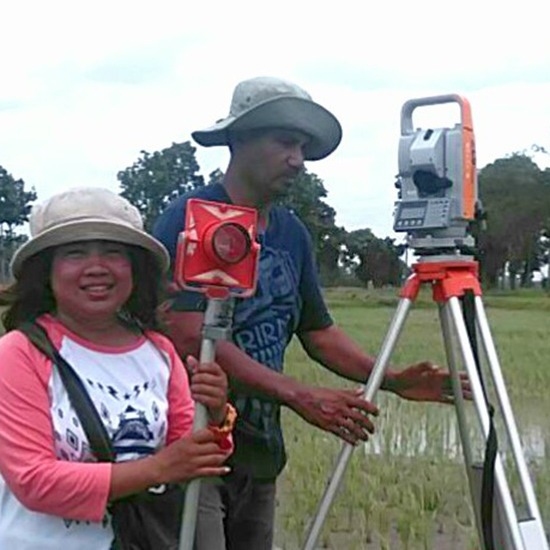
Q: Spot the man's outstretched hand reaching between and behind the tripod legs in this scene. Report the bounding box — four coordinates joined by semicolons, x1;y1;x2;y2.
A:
389;361;472;403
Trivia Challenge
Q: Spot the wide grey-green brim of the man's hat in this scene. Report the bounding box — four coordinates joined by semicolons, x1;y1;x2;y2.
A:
191;96;342;160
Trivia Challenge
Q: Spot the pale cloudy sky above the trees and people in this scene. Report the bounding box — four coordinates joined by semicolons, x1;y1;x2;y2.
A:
0;0;550;237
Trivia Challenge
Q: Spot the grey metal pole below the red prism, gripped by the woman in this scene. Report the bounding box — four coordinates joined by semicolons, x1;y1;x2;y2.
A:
179;298;231;550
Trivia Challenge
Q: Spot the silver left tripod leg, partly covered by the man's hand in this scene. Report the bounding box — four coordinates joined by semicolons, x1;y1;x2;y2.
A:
302;298;412;550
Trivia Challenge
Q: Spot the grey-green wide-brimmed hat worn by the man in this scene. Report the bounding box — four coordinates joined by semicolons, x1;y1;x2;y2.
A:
191;77;342;160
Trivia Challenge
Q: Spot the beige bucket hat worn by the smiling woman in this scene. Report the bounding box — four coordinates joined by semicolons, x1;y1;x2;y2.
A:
11;187;170;278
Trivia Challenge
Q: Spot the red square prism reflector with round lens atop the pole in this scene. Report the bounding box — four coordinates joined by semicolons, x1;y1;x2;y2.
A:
174;199;260;296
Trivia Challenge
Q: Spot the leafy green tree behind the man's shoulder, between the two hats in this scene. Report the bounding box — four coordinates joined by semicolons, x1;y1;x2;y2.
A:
117;141;204;231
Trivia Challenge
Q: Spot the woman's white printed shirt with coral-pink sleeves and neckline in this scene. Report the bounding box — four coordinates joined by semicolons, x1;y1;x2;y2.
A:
0;315;194;550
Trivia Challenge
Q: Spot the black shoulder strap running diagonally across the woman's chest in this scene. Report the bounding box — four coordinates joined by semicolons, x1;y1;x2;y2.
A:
18;323;114;462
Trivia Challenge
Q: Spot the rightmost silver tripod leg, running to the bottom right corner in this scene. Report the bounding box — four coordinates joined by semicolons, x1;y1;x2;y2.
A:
475;297;548;550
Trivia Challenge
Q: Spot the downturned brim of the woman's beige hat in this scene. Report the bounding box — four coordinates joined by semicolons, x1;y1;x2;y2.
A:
10;218;170;278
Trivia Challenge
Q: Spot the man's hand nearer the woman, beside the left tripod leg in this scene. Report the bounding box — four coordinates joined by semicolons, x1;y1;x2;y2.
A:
292;387;378;445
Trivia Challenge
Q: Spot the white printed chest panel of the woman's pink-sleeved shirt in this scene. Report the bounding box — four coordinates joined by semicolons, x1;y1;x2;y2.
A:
50;341;170;528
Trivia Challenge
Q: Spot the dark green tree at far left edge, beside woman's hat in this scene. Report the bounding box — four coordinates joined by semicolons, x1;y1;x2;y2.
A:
0;166;36;281
